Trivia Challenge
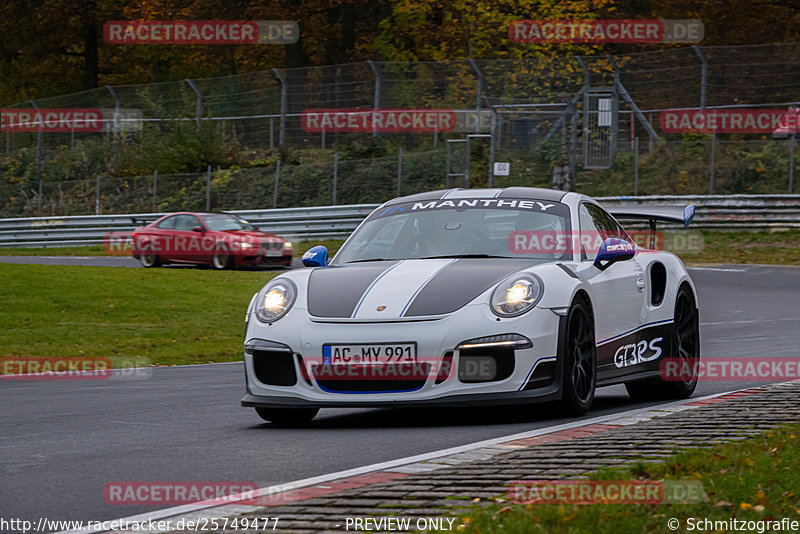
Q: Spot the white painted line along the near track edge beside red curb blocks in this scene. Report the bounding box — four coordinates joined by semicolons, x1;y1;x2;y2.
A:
56;386;753;534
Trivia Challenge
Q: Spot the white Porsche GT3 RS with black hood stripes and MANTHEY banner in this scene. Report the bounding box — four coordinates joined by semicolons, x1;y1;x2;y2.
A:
242;187;700;423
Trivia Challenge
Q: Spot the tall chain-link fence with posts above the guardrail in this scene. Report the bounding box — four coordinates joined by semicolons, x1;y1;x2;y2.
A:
0;43;800;216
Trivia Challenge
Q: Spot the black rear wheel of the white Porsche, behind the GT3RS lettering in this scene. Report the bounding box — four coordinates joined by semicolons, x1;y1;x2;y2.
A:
625;286;700;400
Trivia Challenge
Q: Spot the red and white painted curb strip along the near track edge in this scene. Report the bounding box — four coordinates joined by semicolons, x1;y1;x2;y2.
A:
61;384;782;534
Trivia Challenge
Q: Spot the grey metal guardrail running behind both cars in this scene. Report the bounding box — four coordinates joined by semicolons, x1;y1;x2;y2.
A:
0;195;800;248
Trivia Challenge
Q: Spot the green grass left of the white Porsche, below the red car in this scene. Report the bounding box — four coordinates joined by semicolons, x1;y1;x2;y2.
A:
0;264;276;365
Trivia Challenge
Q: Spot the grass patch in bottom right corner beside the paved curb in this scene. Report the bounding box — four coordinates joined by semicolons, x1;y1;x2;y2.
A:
456;424;800;534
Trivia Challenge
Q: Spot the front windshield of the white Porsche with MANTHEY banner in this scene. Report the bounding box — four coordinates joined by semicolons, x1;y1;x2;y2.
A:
336;198;571;263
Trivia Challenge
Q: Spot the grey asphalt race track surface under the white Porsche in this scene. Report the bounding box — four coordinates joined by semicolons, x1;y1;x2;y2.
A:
0;259;800;521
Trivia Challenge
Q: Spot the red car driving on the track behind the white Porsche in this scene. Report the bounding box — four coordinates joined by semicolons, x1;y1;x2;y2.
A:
132;212;292;269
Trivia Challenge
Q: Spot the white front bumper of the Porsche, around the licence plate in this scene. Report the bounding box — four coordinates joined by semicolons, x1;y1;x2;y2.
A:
242;304;561;407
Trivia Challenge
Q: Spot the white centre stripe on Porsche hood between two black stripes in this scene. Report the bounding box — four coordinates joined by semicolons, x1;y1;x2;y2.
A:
353;258;454;319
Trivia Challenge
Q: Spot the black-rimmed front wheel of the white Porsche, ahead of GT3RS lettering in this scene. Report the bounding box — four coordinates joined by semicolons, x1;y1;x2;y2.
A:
561;297;597;415
